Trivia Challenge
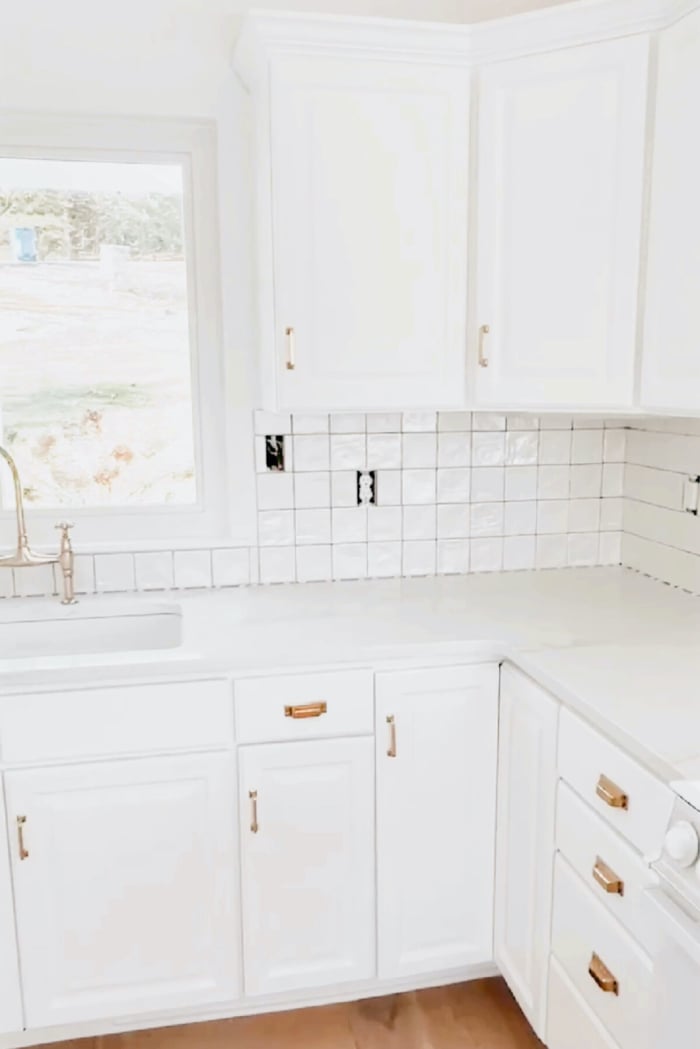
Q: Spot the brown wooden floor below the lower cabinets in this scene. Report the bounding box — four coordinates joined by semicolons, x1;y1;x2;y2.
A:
39;980;542;1049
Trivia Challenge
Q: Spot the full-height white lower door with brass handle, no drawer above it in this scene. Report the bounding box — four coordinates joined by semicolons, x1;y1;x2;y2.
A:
377;665;499;979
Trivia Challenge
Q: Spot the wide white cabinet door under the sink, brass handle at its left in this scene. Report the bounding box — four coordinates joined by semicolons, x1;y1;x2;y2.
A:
6;754;239;1027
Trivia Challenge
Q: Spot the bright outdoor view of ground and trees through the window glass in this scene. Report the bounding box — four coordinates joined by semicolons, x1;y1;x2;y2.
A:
0;158;196;508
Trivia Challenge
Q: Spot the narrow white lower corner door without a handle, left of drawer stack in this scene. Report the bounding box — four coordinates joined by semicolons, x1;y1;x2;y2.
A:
494;666;558;1040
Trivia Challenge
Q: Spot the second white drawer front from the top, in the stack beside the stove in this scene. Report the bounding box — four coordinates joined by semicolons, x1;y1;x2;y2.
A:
556;780;656;954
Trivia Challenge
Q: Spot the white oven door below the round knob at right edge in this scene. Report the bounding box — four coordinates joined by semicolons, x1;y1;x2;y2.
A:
644;887;700;1049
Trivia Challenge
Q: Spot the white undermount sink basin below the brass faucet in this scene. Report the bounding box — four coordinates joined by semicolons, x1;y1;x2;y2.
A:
0;597;183;660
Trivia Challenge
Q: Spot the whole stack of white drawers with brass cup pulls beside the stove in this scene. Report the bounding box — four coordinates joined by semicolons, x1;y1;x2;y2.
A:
548;711;673;1049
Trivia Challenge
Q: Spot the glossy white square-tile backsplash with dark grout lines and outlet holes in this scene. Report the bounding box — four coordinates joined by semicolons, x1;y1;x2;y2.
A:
5;411;642;596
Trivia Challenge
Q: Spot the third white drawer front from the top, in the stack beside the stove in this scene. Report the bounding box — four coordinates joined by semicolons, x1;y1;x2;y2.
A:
552;856;653;1049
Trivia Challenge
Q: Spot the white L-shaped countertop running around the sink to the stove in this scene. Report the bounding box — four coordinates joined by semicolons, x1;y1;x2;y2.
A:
0;569;700;780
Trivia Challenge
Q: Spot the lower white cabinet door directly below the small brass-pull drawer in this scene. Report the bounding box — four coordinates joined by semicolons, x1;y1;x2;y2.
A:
240;738;375;994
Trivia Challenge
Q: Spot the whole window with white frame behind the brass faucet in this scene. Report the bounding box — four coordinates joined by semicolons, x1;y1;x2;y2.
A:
0;122;224;541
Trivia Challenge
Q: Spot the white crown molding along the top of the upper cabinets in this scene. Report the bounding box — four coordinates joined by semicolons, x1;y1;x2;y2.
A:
234;0;700;87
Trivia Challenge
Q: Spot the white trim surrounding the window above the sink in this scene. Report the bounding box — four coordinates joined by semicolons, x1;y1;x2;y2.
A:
0;114;250;552
